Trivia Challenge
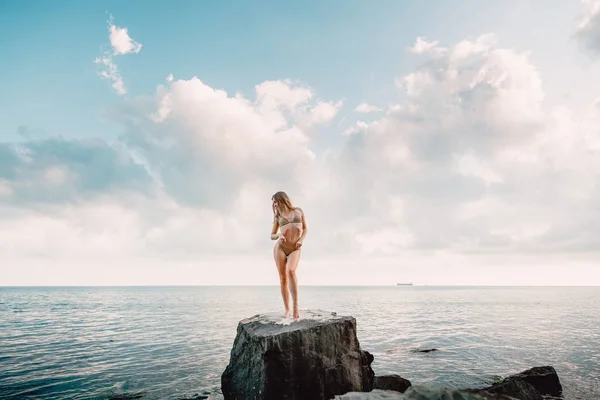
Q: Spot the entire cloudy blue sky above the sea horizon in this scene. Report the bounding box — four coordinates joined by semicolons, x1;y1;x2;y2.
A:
0;0;600;286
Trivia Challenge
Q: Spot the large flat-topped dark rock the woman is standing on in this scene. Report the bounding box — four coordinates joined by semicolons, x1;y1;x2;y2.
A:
221;310;374;400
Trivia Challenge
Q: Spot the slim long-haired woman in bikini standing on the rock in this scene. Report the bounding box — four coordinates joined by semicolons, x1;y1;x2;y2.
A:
271;192;307;320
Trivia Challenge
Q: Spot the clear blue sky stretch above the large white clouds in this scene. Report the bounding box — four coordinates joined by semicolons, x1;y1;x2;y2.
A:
0;1;591;144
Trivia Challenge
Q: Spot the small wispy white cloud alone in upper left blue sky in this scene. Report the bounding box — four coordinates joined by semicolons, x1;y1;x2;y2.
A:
94;16;142;96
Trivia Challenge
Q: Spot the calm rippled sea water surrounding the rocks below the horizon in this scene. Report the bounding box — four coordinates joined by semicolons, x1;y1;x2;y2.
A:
0;286;600;400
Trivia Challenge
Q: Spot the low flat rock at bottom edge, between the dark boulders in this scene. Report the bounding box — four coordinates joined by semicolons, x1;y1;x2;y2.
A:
335;386;515;400
